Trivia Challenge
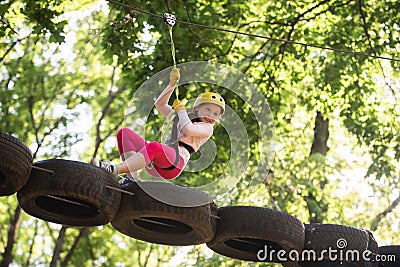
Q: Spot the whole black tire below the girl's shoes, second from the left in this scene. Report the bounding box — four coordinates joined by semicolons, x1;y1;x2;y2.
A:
17;159;121;226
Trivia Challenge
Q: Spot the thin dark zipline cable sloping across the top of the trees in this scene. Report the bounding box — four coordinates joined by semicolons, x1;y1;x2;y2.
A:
107;0;400;62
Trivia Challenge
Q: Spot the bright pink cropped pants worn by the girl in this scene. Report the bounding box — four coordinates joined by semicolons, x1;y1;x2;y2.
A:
117;128;185;180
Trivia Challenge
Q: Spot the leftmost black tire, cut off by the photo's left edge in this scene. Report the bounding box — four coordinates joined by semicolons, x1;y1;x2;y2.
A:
0;132;33;196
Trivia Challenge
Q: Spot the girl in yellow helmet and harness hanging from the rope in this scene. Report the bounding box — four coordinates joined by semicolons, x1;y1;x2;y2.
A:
92;68;225;184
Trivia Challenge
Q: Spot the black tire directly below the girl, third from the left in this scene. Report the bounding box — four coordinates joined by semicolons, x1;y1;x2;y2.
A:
111;181;217;246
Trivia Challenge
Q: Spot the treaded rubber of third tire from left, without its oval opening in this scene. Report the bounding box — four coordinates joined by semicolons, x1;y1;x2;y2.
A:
111;182;218;246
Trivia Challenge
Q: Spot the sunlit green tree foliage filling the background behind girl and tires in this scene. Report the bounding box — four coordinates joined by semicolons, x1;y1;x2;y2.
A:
0;0;400;266
